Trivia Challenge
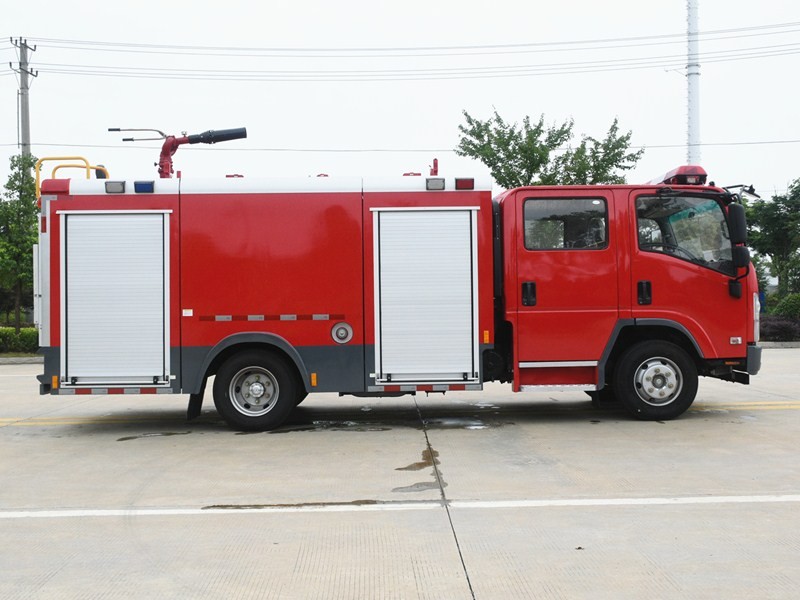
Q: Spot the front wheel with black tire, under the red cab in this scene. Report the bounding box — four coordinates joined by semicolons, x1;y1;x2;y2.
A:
614;341;697;421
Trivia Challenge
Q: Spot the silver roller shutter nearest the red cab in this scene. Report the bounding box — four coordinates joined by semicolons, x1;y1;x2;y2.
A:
374;209;478;383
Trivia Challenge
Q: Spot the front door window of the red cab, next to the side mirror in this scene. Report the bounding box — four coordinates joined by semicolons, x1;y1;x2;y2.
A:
636;196;736;275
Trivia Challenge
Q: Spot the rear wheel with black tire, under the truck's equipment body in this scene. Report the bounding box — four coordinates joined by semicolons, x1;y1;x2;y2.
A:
214;350;299;431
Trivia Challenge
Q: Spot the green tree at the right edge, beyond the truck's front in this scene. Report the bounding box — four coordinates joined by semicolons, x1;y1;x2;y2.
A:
747;179;800;298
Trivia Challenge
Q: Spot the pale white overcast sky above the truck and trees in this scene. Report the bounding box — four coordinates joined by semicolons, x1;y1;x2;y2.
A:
0;0;800;197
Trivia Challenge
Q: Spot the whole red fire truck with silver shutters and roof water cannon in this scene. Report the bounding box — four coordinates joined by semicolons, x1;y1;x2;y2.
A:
35;129;761;431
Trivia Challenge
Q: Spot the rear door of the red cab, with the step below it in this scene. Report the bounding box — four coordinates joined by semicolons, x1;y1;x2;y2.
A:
507;188;619;387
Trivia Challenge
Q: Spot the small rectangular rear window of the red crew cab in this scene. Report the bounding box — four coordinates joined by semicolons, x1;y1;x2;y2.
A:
523;198;608;250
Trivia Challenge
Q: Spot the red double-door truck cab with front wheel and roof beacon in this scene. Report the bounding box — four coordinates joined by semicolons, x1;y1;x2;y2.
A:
493;168;760;419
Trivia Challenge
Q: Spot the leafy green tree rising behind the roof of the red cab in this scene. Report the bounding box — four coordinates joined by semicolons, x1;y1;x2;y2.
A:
456;110;644;189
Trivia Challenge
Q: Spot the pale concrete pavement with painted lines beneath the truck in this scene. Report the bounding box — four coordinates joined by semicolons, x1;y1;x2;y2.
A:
0;349;800;599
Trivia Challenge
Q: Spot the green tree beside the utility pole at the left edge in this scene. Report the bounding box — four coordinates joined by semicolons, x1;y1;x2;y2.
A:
0;154;38;332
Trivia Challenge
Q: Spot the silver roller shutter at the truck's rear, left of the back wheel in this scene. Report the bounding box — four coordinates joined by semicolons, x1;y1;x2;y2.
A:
62;213;169;385
